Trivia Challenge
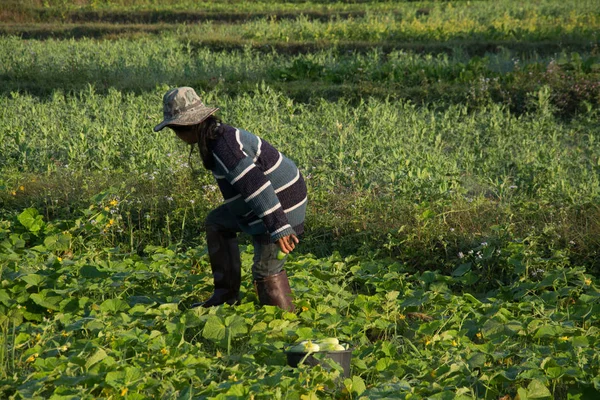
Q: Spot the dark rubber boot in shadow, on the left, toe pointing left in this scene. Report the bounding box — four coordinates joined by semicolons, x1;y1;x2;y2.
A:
192;229;242;307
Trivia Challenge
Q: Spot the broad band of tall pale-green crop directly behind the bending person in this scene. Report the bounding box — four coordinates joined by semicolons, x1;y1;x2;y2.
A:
0;86;600;268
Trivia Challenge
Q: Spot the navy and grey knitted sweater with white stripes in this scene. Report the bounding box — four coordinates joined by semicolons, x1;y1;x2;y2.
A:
210;124;307;242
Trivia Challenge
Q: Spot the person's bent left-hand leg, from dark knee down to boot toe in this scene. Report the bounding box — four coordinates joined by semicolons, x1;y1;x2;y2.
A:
192;205;242;307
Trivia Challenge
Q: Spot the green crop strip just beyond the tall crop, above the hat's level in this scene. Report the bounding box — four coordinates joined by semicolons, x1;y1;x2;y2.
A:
0;37;600;117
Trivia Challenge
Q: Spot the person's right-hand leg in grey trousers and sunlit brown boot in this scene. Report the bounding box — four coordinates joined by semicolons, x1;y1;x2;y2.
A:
252;236;295;311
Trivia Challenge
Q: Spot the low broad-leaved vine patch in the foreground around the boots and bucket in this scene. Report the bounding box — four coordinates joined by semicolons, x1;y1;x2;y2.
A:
0;209;600;399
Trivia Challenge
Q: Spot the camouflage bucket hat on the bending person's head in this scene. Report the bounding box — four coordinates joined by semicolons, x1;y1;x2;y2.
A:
154;87;218;132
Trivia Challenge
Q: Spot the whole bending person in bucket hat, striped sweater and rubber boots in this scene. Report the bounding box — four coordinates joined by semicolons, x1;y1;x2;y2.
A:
154;87;307;311
